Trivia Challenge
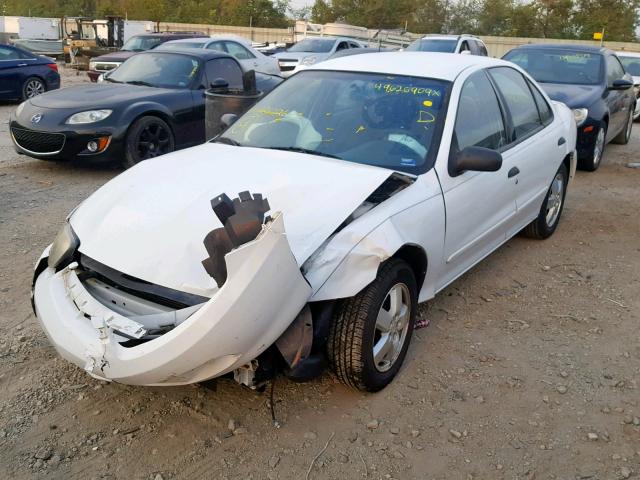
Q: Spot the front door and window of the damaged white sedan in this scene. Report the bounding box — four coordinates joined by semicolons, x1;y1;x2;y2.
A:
436;70;516;289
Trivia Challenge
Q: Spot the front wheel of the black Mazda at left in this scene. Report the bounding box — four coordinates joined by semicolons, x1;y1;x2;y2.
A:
123;115;175;168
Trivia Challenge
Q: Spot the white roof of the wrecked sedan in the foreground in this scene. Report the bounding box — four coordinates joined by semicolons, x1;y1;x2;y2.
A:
307;52;513;81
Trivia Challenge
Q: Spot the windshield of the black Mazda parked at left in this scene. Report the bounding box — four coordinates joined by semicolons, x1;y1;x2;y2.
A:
105;52;200;88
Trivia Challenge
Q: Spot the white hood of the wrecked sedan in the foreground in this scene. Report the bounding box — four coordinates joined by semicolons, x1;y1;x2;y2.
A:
70;143;392;296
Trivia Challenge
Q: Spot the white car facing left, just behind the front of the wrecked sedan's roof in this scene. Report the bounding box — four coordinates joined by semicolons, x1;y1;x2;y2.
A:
273;37;366;77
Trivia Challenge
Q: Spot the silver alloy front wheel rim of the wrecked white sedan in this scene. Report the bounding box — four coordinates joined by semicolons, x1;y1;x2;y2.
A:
373;283;412;372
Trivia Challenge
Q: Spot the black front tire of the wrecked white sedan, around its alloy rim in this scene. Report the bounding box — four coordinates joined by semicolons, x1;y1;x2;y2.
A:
327;259;418;392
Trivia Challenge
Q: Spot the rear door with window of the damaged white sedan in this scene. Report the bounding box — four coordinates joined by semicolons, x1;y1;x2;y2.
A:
489;67;567;233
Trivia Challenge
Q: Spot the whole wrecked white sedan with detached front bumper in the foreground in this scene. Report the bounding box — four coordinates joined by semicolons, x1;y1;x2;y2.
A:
34;52;576;391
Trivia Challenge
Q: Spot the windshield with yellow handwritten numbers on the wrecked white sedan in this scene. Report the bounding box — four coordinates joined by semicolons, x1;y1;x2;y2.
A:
219;71;449;174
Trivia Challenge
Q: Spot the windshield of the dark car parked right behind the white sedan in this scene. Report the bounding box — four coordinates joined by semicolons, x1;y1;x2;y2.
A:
503;49;602;85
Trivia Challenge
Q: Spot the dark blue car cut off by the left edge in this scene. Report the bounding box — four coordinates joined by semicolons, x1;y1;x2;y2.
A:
0;45;60;100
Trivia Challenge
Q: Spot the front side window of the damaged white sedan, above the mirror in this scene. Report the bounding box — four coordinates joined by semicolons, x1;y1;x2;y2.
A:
452;71;507;151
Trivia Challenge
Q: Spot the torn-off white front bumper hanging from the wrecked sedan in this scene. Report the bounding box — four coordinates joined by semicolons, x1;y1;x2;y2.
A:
34;215;311;385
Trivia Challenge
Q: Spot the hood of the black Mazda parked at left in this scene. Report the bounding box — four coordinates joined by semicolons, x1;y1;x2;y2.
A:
29;82;176;110
